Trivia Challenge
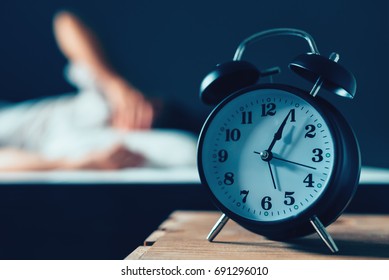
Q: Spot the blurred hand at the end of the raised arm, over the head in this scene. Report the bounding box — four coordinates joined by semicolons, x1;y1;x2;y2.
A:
103;78;154;131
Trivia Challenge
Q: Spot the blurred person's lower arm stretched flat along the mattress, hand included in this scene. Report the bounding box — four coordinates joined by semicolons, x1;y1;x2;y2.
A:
0;145;144;172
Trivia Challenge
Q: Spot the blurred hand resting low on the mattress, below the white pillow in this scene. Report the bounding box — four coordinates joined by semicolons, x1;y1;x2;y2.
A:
74;144;145;170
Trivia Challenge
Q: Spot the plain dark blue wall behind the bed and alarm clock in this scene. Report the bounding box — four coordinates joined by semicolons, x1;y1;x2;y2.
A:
0;0;389;166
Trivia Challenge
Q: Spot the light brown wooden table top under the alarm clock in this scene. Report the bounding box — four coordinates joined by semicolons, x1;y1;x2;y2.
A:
126;211;389;260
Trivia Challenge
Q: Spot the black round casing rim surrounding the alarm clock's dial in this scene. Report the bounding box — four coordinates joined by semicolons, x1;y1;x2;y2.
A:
197;84;361;239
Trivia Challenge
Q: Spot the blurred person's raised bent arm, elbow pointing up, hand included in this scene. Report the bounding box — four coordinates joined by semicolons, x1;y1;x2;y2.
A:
54;11;154;130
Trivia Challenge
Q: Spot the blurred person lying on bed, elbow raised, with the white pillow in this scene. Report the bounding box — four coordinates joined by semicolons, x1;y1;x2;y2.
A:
0;11;196;171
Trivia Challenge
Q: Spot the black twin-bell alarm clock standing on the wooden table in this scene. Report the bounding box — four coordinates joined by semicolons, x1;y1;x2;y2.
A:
198;28;361;252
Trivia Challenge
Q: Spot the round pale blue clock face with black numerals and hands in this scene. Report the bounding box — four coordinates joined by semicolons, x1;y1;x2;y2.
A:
199;88;335;222
